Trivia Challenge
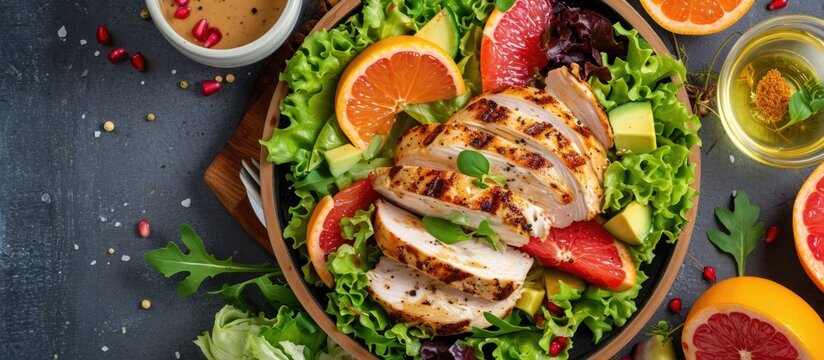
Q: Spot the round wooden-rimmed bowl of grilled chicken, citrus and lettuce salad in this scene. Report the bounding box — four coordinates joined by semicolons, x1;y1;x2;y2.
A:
261;0;700;359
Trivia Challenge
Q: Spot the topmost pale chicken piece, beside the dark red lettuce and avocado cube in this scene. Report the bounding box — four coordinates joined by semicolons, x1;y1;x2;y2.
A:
545;64;613;149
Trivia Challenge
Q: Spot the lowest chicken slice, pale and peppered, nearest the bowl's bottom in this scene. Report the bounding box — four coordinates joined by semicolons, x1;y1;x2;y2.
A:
366;256;523;336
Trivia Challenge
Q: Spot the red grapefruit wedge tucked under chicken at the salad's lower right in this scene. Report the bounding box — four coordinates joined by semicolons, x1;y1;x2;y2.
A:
521;219;636;291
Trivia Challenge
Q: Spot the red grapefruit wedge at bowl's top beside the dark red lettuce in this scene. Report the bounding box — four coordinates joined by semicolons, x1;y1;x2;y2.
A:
481;0;552;91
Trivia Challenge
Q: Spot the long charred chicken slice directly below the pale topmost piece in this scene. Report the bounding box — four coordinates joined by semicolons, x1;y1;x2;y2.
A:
476;87;609;181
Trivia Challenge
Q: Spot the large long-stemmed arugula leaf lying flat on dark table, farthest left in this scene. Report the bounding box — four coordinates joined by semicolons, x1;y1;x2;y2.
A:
143;224;279;297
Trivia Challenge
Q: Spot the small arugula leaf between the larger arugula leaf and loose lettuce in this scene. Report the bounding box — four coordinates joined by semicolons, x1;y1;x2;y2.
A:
209;270;300;310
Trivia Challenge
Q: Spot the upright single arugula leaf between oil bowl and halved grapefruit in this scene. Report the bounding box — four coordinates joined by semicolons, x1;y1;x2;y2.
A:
707;191;766;276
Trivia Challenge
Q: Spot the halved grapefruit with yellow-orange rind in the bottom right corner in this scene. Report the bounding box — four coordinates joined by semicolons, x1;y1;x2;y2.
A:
681;276;824;360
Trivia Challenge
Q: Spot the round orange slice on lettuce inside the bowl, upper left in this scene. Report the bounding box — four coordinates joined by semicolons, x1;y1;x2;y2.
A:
335;36;466;149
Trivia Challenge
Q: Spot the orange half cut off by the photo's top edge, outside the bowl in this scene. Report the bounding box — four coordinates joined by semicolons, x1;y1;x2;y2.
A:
641;0;753;35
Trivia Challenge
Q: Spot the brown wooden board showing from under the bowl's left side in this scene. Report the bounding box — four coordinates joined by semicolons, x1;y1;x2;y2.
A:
203;0;337;254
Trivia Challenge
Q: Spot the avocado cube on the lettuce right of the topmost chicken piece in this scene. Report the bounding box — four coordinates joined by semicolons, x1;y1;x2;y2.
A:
609;102;658;154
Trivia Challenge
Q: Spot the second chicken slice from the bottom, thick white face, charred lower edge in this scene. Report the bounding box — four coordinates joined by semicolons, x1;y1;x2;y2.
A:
375;200;533;301
